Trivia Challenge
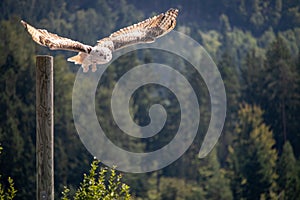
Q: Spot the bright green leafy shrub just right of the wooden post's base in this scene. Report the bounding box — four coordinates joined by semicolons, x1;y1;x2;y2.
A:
61;160;131;200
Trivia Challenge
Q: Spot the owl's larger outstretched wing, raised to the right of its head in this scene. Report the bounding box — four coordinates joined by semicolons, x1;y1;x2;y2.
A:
97;9;178;51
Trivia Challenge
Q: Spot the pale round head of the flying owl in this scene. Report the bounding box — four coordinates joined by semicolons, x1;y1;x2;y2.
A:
90;46;112;64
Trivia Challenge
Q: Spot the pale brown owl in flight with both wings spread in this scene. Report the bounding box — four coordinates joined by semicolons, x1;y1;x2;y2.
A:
21;9;178;72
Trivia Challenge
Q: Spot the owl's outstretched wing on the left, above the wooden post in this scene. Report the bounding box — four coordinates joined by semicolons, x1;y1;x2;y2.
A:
21;20;92;53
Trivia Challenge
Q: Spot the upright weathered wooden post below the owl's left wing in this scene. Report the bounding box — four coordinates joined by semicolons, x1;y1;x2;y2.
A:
36;55;54;200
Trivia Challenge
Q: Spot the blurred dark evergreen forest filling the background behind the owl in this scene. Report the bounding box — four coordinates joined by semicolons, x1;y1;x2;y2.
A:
0;0;300;200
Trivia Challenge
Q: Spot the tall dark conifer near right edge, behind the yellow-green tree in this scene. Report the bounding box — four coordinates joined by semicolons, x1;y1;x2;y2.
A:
260;37;299;150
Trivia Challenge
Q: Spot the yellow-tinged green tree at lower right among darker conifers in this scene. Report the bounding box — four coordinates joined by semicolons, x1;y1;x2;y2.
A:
228;104;277;199
